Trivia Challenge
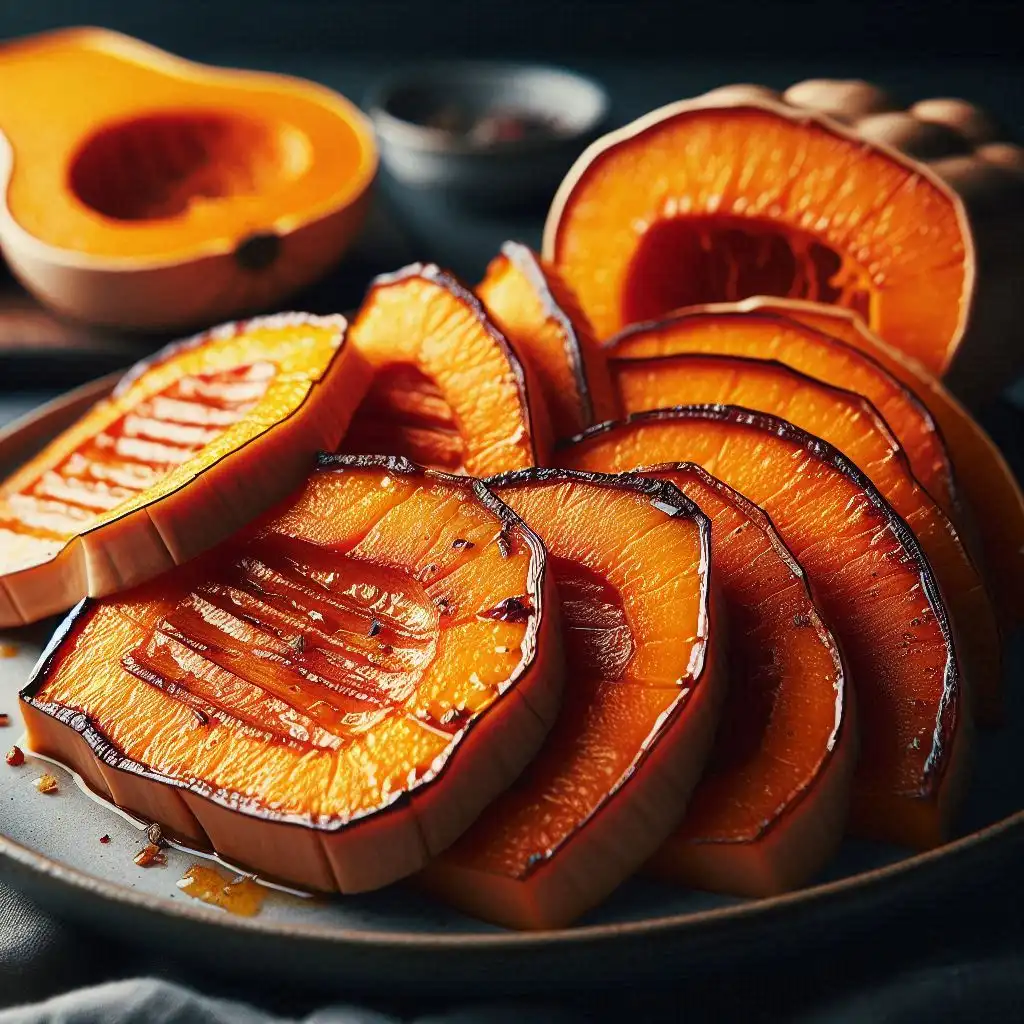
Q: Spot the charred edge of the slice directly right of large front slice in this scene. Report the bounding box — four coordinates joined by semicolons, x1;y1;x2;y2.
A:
484;466;720;882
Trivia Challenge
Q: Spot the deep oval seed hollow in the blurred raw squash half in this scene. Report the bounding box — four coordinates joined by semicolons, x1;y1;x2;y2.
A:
69;111;310;220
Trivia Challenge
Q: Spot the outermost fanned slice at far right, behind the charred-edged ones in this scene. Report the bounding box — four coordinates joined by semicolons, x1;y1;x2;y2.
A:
744;298;1024;623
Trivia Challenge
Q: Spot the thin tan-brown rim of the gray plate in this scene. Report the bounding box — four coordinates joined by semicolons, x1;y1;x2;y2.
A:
0;374;1024;952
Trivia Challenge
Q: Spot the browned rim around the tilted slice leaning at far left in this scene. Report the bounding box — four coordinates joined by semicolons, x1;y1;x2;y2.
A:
0;313;354;617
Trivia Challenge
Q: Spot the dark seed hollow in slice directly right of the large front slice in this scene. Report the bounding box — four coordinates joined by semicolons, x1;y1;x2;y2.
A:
549;557;635;681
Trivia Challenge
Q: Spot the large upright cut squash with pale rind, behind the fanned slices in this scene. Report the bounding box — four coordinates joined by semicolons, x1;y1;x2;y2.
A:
544;96;974;374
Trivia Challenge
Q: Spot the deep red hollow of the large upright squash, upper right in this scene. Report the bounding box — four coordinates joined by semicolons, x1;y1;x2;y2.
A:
622;216;871;324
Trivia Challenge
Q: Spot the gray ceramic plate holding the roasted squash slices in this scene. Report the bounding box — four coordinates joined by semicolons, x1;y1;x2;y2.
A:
0;379;1024;993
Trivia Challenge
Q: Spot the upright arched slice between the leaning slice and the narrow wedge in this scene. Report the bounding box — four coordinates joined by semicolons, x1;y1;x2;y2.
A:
344;263;551;476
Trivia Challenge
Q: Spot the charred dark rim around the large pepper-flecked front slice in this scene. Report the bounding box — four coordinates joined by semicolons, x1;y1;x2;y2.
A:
18;452;548;834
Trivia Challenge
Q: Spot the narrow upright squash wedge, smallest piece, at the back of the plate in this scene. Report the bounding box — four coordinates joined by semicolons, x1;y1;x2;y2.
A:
476;242;618;437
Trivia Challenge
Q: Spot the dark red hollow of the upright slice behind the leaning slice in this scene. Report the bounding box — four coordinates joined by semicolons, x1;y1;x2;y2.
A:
345;362;466;472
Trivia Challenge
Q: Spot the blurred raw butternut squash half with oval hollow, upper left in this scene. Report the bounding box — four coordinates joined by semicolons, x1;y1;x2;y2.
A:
0;29;377;330
